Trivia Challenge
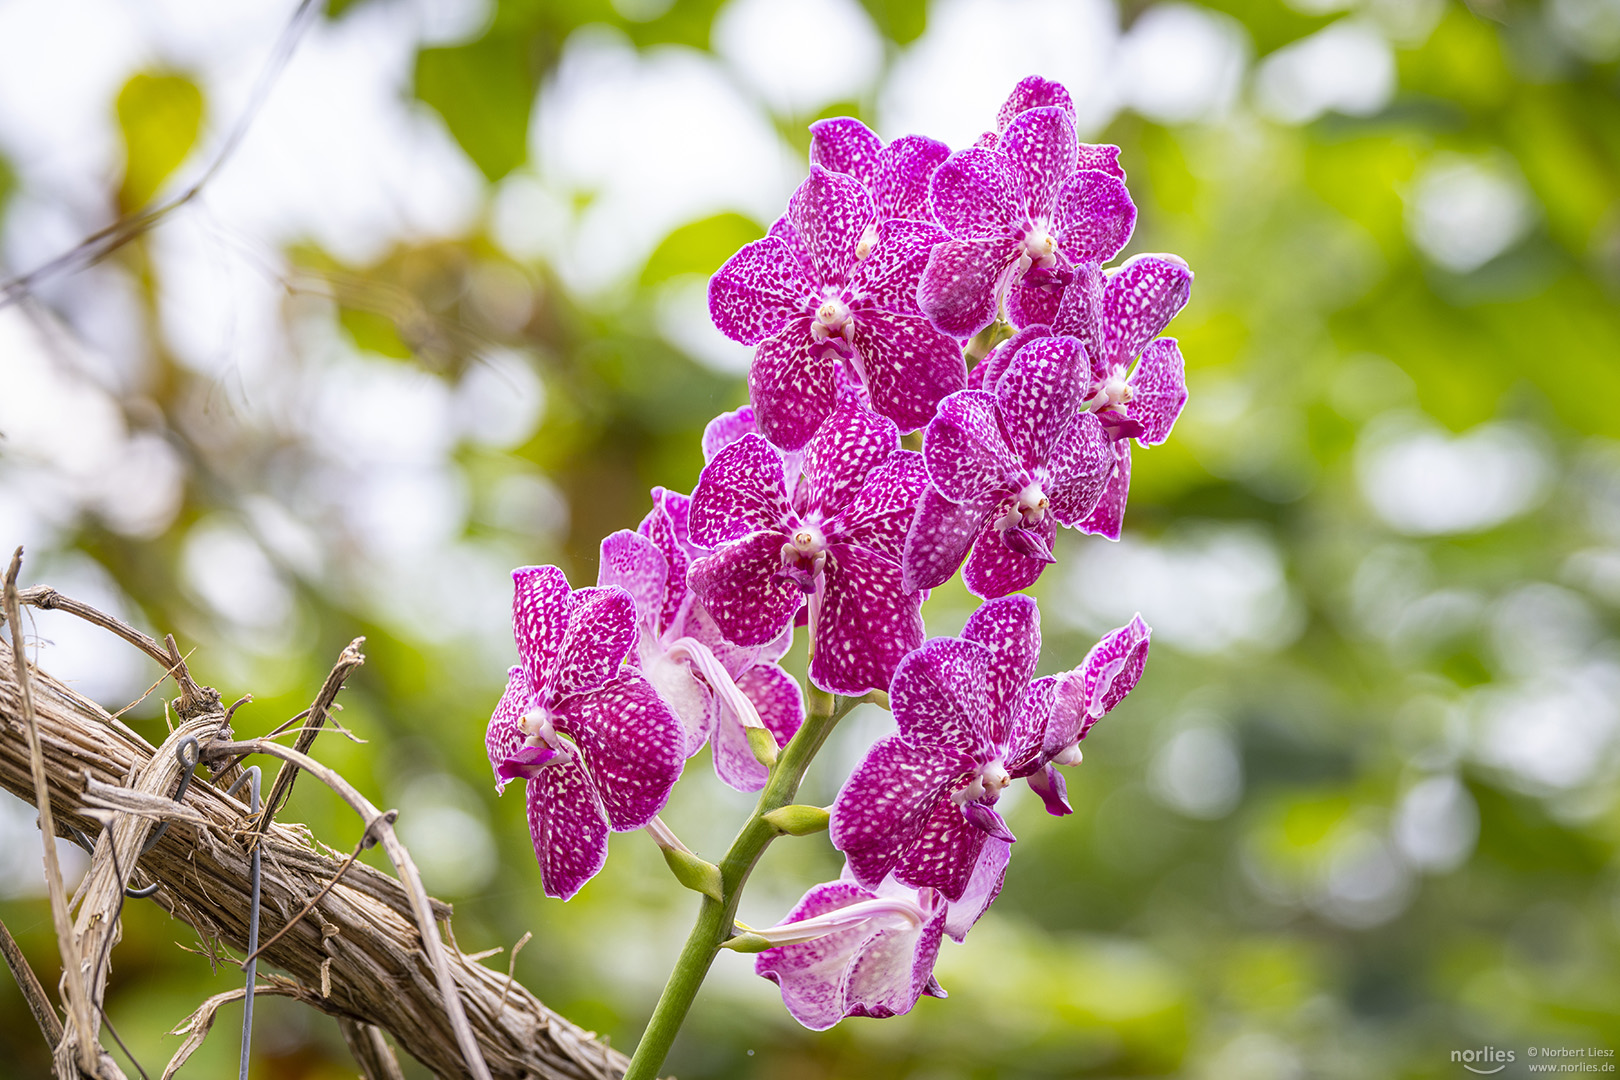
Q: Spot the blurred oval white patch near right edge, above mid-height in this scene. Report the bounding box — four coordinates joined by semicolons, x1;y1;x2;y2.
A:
1356;413;1552;536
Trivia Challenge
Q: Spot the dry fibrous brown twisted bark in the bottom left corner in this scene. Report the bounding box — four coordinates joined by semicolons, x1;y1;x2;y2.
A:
0;625;627;1080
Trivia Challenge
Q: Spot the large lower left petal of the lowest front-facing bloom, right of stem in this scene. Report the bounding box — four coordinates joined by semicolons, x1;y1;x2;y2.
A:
829;735;983;895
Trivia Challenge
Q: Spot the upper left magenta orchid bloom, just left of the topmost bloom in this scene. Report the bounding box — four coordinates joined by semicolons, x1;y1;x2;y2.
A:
710;165;967;450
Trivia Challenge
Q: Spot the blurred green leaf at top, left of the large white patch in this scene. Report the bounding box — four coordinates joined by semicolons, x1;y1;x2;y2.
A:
416;31;539;180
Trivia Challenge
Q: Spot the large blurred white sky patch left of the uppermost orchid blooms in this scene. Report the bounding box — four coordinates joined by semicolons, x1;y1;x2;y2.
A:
530;26;805;293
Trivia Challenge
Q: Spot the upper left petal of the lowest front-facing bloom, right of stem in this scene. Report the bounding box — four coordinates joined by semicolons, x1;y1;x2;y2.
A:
889;638;993;759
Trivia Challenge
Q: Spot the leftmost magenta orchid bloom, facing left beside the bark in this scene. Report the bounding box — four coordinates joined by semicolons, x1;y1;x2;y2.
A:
484;567;685;900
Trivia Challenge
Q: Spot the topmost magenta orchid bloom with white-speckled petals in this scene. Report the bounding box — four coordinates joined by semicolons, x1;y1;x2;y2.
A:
917;91;1136;337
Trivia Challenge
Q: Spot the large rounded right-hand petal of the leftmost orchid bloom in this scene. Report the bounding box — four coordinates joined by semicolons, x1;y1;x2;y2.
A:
556;672;687;832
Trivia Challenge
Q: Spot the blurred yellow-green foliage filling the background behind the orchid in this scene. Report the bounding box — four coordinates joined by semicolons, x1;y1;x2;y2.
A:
0;0;1620;1080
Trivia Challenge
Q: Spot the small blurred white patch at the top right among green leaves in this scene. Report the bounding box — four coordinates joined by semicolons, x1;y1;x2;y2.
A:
1256;18;1395;123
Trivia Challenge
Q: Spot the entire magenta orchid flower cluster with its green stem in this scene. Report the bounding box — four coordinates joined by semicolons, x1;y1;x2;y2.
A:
486;78;1192;1075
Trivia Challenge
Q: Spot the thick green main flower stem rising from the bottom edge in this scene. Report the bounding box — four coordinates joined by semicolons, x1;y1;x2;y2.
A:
624;687;860;1080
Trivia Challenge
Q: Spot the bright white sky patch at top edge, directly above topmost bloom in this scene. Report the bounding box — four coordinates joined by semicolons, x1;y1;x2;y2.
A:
878;0;1119;149
